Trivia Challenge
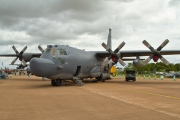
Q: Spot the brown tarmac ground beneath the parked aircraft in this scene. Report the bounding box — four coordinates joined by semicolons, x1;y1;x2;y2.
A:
0;76;180;120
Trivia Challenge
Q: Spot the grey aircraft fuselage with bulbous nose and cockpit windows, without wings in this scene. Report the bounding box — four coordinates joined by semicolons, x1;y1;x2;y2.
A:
30;45;102;80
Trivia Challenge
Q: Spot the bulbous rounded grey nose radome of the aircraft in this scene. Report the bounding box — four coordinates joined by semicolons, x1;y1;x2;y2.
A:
30;58;55;77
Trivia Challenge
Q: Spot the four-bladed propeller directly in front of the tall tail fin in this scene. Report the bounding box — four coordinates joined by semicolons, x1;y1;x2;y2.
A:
102;42;126;66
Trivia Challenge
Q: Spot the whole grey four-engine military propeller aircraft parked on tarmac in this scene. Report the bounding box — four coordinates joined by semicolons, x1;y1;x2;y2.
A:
0;29;180;86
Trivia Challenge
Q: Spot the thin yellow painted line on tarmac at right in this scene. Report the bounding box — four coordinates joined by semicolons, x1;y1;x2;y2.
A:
101;85;180;100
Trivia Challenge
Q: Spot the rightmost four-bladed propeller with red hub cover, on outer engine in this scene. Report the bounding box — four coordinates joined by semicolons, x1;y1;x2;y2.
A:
142;39;169;65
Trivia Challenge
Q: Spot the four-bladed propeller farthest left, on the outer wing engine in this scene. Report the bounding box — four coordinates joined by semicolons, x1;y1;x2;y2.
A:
11;46;27;66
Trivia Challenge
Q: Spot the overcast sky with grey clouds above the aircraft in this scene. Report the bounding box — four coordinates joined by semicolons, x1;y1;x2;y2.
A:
0;0;180;68
